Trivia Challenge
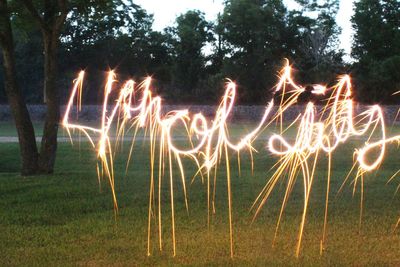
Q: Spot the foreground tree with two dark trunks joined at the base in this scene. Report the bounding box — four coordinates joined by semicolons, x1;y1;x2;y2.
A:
0;0;155;174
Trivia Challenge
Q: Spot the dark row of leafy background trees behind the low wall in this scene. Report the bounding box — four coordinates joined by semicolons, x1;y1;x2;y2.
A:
0;0;400;104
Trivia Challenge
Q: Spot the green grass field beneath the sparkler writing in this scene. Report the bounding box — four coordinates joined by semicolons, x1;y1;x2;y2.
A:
0;124;400;266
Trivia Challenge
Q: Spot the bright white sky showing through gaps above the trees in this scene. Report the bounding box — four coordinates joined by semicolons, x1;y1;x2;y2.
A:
135;0;354;57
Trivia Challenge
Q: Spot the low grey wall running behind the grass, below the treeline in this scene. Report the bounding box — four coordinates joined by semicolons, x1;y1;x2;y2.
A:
0;105;399;123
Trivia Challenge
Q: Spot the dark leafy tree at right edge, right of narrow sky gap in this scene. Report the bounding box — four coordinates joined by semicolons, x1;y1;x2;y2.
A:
352;0;400;103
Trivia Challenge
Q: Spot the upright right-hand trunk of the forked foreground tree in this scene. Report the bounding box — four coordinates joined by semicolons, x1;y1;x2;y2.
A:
39;31;60;173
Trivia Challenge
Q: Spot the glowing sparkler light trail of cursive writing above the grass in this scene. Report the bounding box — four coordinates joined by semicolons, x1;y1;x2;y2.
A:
62;62;400;256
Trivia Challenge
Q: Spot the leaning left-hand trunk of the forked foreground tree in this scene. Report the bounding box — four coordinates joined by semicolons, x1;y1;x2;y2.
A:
0;0;38;175
